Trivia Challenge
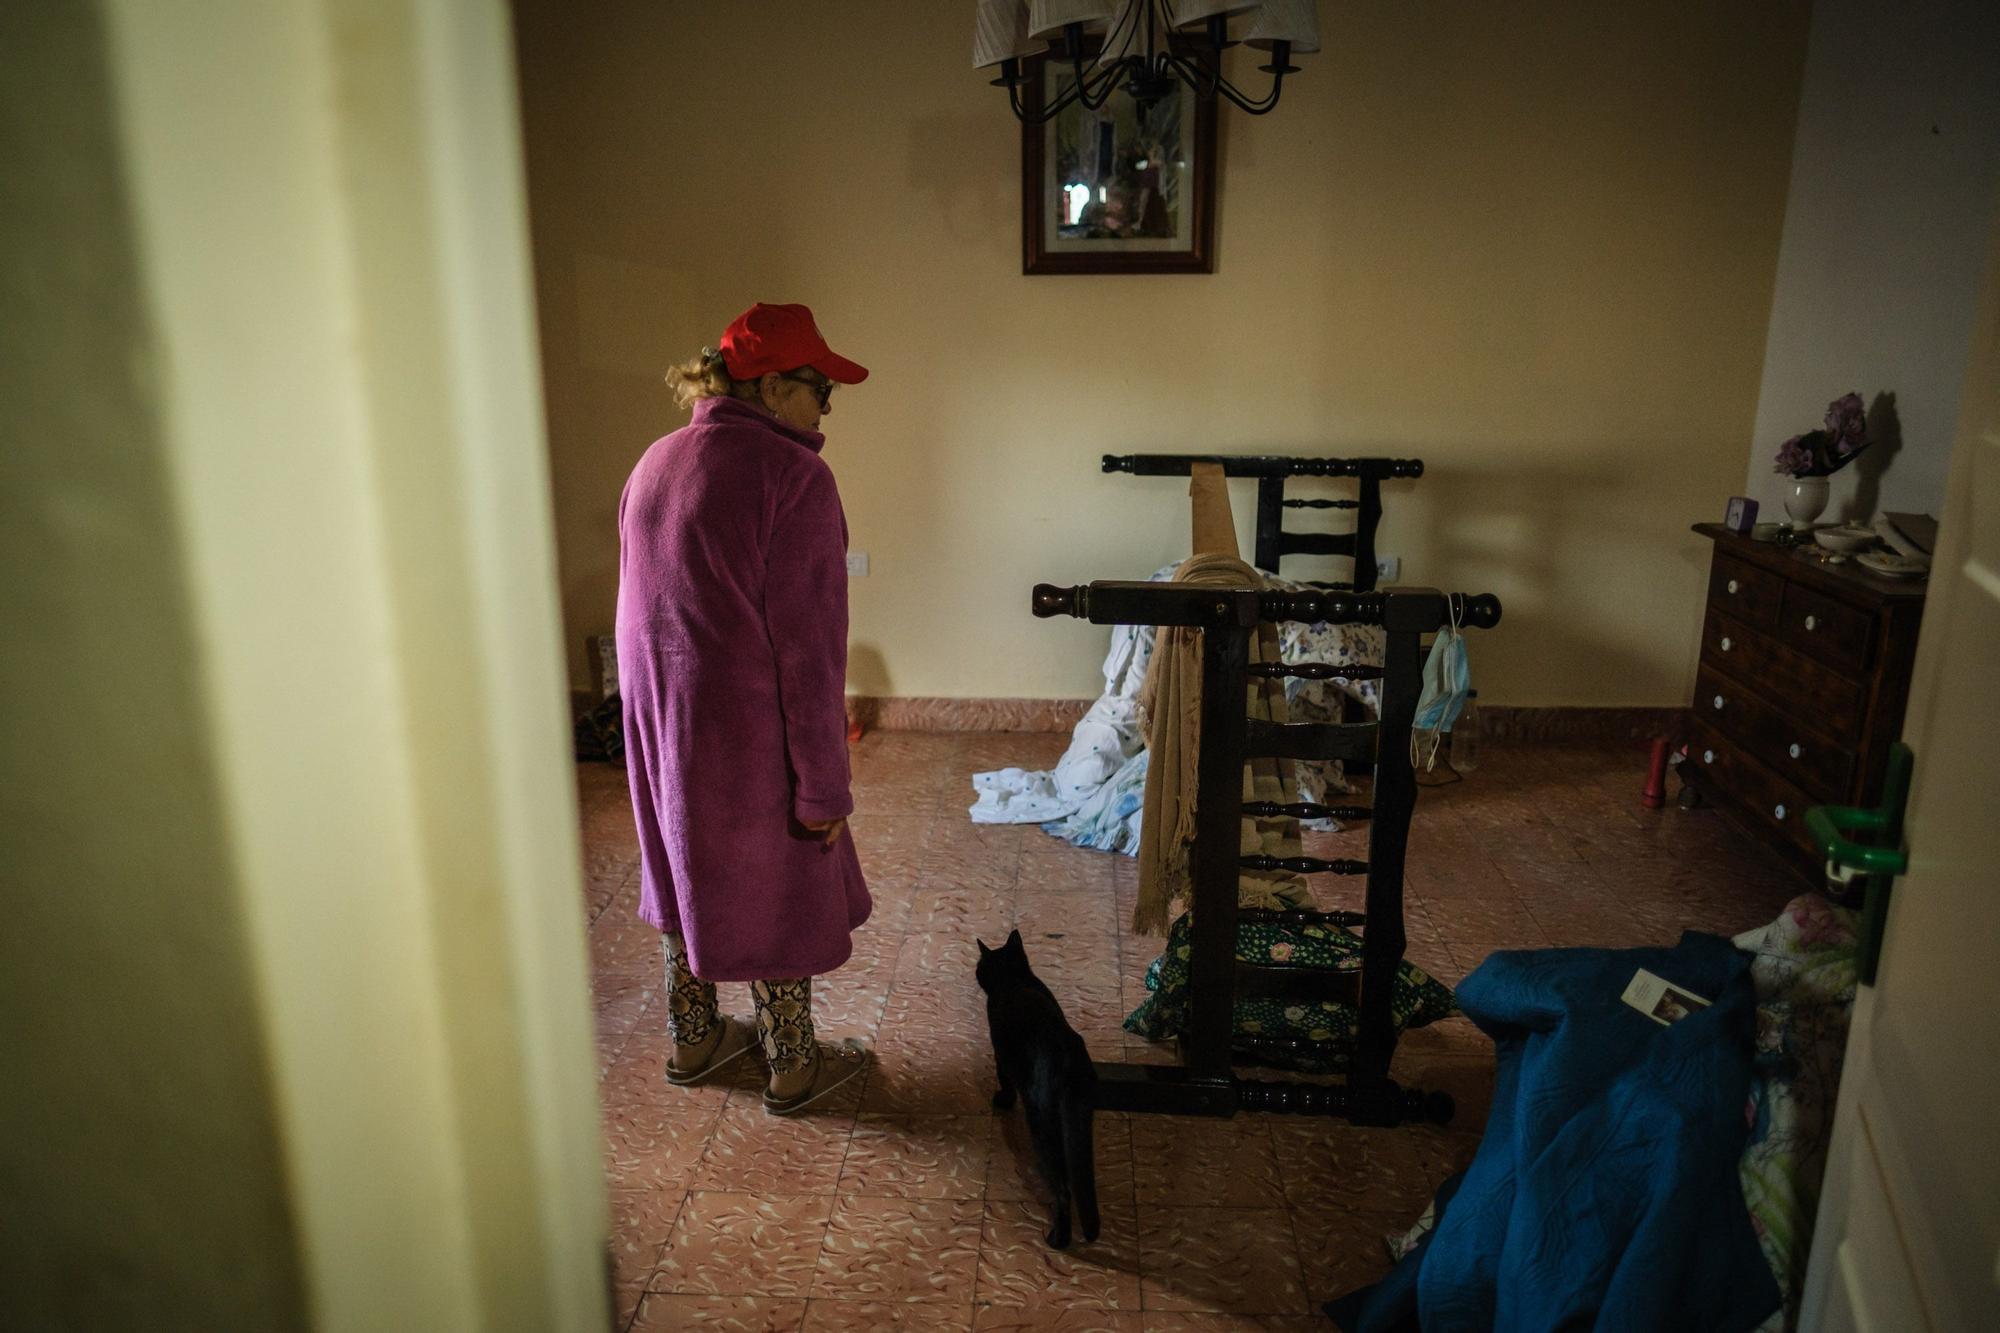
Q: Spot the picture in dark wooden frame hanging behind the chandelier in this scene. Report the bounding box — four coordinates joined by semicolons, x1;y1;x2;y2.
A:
1020;43;1216;272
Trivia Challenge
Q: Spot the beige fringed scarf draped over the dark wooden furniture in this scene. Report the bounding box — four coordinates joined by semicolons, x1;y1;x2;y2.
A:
1132;556;1312;935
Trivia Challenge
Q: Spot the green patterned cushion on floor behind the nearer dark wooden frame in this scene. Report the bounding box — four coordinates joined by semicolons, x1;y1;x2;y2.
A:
1124;913;1456;1073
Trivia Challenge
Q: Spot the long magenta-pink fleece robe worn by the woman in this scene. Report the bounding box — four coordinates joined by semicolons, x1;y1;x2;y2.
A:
618;398;870;981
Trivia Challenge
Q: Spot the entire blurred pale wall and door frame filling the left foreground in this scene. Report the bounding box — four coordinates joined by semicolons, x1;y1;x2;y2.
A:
0;0;608;1333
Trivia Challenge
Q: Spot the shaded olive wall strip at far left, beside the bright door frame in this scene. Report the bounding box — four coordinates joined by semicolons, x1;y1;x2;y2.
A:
0;6;306;1329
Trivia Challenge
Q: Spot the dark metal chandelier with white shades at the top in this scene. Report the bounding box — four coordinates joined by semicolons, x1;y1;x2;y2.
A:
972;0;1320;124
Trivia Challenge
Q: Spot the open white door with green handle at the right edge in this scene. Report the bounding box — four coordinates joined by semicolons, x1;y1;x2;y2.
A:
1800;226;2000;1333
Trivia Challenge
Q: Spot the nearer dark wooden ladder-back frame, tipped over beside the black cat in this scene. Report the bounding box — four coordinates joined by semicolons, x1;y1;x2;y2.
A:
1032;582;1500;1125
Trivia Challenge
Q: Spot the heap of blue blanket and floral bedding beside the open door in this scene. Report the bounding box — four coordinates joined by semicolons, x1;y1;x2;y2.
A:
1326;895;1858;1333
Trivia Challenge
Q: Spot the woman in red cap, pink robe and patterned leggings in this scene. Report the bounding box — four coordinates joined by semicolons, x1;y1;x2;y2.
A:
618;304;870;1115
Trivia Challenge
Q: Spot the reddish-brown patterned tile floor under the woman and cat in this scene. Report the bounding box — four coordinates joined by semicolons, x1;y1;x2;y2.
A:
578;733;1800;1333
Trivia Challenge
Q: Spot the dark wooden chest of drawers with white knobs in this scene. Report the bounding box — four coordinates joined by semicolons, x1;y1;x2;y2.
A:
1680;522;1926;877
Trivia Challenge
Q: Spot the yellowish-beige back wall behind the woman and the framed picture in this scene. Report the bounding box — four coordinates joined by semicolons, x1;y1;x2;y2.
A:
516;0;1806;705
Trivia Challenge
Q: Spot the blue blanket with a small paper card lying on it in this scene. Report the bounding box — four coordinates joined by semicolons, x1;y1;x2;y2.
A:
1328;931;1780;1333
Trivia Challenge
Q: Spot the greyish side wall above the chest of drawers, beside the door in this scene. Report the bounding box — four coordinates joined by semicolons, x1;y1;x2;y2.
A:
1744;0;2000;520
